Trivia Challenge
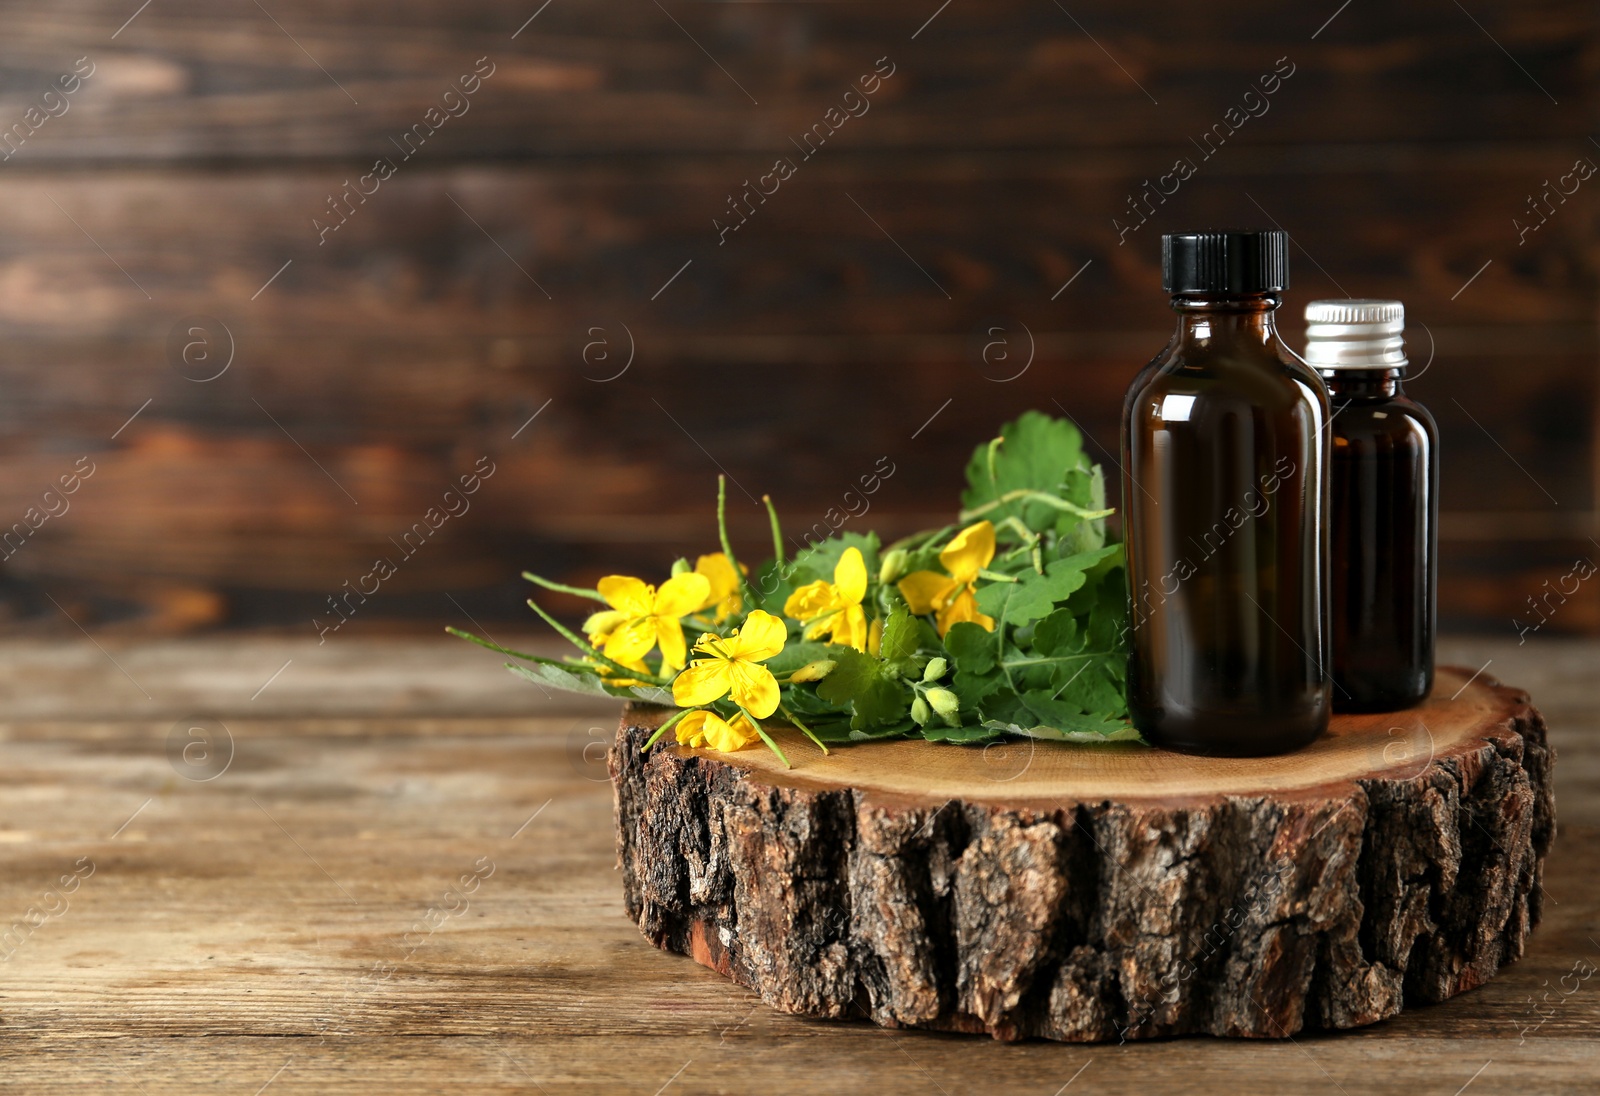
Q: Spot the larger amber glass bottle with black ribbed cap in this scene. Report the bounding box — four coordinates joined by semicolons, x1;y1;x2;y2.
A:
1122;232;1330;755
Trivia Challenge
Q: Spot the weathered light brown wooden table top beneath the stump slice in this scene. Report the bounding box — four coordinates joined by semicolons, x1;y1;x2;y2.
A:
0;635;1600;1096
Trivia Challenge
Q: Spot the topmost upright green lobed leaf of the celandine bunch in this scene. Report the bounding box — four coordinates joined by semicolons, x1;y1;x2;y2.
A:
962;411;1088;539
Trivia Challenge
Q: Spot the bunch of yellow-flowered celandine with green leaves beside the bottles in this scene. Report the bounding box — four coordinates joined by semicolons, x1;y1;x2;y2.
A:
446;413;1133;755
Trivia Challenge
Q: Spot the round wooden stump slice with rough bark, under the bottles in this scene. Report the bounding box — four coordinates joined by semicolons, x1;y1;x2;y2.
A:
610;669;1555;1042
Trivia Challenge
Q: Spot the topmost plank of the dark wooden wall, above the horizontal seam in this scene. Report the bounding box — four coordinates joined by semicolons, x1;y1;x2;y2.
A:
3;0;1595;162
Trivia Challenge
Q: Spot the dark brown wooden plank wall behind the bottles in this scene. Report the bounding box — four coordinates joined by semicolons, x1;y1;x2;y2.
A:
0;0;1600;634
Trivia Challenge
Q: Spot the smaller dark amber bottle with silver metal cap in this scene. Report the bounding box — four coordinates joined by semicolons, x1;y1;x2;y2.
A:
1306;301;1438;712
